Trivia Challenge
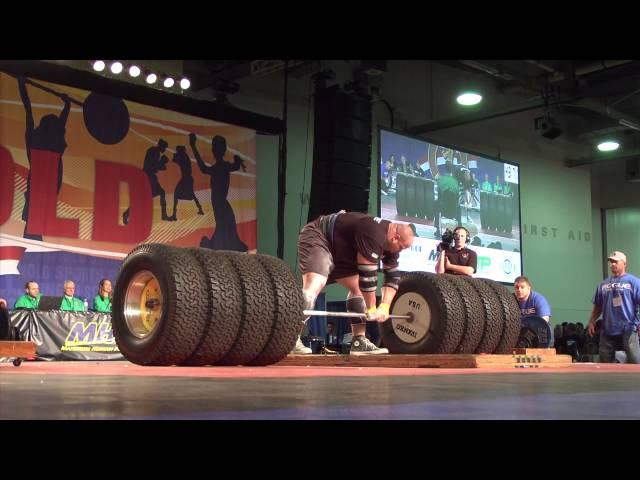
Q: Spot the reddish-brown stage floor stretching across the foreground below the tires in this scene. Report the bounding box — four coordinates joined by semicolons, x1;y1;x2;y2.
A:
0;361;640;420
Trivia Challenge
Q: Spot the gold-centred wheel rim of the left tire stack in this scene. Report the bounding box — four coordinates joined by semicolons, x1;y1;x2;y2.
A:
124;270;164;338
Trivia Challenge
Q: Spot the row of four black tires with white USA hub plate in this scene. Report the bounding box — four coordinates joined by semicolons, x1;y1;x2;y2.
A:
381;272;520;354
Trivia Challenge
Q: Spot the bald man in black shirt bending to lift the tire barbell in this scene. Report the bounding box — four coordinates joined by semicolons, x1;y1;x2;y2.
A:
291;211;415;355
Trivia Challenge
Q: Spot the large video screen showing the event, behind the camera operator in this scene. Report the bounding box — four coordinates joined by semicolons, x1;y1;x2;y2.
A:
378;128;522;283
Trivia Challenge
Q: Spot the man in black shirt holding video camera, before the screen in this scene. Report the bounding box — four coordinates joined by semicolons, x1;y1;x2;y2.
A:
436;227;478;277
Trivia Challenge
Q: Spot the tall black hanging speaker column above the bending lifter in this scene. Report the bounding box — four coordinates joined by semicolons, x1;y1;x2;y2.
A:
308;85;371;221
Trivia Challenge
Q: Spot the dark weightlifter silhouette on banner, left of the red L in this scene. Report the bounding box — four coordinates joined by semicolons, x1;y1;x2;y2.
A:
18;77;71;240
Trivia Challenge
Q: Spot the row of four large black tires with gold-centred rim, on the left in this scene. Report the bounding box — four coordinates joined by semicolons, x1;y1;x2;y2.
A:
112;244;304;366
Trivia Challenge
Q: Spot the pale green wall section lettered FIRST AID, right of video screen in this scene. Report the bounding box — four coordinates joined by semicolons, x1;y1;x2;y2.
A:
520;159;602;324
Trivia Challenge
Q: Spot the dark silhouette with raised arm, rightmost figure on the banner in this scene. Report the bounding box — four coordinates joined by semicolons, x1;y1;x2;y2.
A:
189;133;249;252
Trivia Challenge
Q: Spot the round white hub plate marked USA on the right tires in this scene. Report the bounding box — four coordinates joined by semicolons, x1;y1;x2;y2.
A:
391;292;431;343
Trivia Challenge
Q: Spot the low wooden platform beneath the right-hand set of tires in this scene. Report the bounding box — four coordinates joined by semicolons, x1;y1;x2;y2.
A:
276;348;572;368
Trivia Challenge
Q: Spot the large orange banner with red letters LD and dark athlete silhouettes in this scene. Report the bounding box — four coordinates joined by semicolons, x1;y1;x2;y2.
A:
0;73;257;307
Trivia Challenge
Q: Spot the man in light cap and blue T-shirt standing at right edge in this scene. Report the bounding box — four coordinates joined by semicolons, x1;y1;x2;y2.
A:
587;251;640;363
